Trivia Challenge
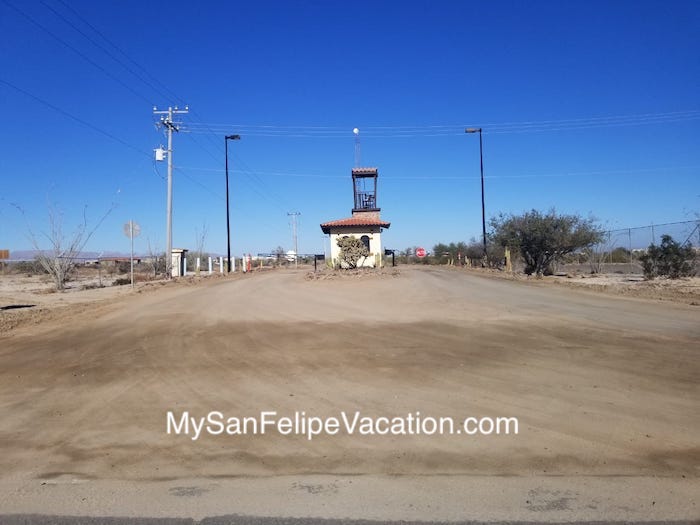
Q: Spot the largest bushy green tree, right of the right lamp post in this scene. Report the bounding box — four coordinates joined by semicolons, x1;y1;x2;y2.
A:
491;209;603;277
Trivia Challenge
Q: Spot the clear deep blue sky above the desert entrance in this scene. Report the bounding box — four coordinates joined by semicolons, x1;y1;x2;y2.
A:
0;0;700;254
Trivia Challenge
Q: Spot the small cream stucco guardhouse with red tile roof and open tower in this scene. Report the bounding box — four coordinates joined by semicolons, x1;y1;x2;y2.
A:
321;168;391;268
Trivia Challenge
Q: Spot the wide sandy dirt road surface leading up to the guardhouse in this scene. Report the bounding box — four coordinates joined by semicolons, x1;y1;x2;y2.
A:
0;267;700;521
